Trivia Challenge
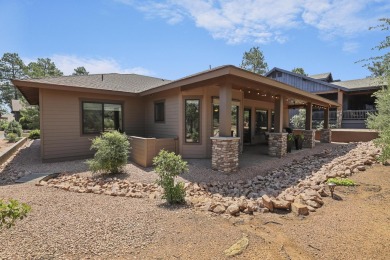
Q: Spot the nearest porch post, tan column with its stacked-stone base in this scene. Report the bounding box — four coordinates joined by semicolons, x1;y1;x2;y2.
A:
210;84;240;173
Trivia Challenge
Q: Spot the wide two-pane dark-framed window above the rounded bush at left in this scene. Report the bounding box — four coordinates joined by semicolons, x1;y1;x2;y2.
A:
82;102;122;134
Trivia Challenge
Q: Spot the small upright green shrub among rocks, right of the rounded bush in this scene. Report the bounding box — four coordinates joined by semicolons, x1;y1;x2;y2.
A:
153;150;188;204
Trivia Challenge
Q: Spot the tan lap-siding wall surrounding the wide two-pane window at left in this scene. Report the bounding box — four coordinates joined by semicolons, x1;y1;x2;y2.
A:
40;89;144;161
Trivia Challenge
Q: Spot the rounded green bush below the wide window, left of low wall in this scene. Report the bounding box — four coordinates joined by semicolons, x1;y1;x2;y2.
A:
87;131;130;174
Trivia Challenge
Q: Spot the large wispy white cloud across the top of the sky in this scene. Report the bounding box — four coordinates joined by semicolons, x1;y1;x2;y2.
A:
115;0;387;44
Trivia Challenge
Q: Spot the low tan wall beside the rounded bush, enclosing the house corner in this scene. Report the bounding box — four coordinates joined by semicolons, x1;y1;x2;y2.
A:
129;136;179;167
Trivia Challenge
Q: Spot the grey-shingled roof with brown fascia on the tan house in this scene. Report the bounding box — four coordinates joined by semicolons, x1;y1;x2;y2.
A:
12;65;338;106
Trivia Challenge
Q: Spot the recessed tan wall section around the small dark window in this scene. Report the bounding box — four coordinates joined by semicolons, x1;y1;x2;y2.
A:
144;89;180;138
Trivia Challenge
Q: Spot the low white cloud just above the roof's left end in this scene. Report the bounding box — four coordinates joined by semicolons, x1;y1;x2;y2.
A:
50;55;153;76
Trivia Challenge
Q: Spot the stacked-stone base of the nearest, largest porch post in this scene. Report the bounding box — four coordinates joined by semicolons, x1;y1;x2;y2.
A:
210;137;240;173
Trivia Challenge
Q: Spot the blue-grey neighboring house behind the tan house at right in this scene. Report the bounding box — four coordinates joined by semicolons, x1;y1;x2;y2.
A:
266;68;384;128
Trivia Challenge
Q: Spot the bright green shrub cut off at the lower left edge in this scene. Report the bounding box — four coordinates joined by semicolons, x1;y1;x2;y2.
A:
0;199;31;228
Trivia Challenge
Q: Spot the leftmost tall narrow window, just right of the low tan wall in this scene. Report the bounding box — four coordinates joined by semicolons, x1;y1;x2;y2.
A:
185;99;200;143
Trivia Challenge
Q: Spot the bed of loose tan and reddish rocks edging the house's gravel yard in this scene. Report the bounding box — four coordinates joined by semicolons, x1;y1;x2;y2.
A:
37;142;380;216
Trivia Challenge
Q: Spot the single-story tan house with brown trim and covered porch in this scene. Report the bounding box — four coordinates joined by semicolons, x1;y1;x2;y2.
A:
12;65;338;171
